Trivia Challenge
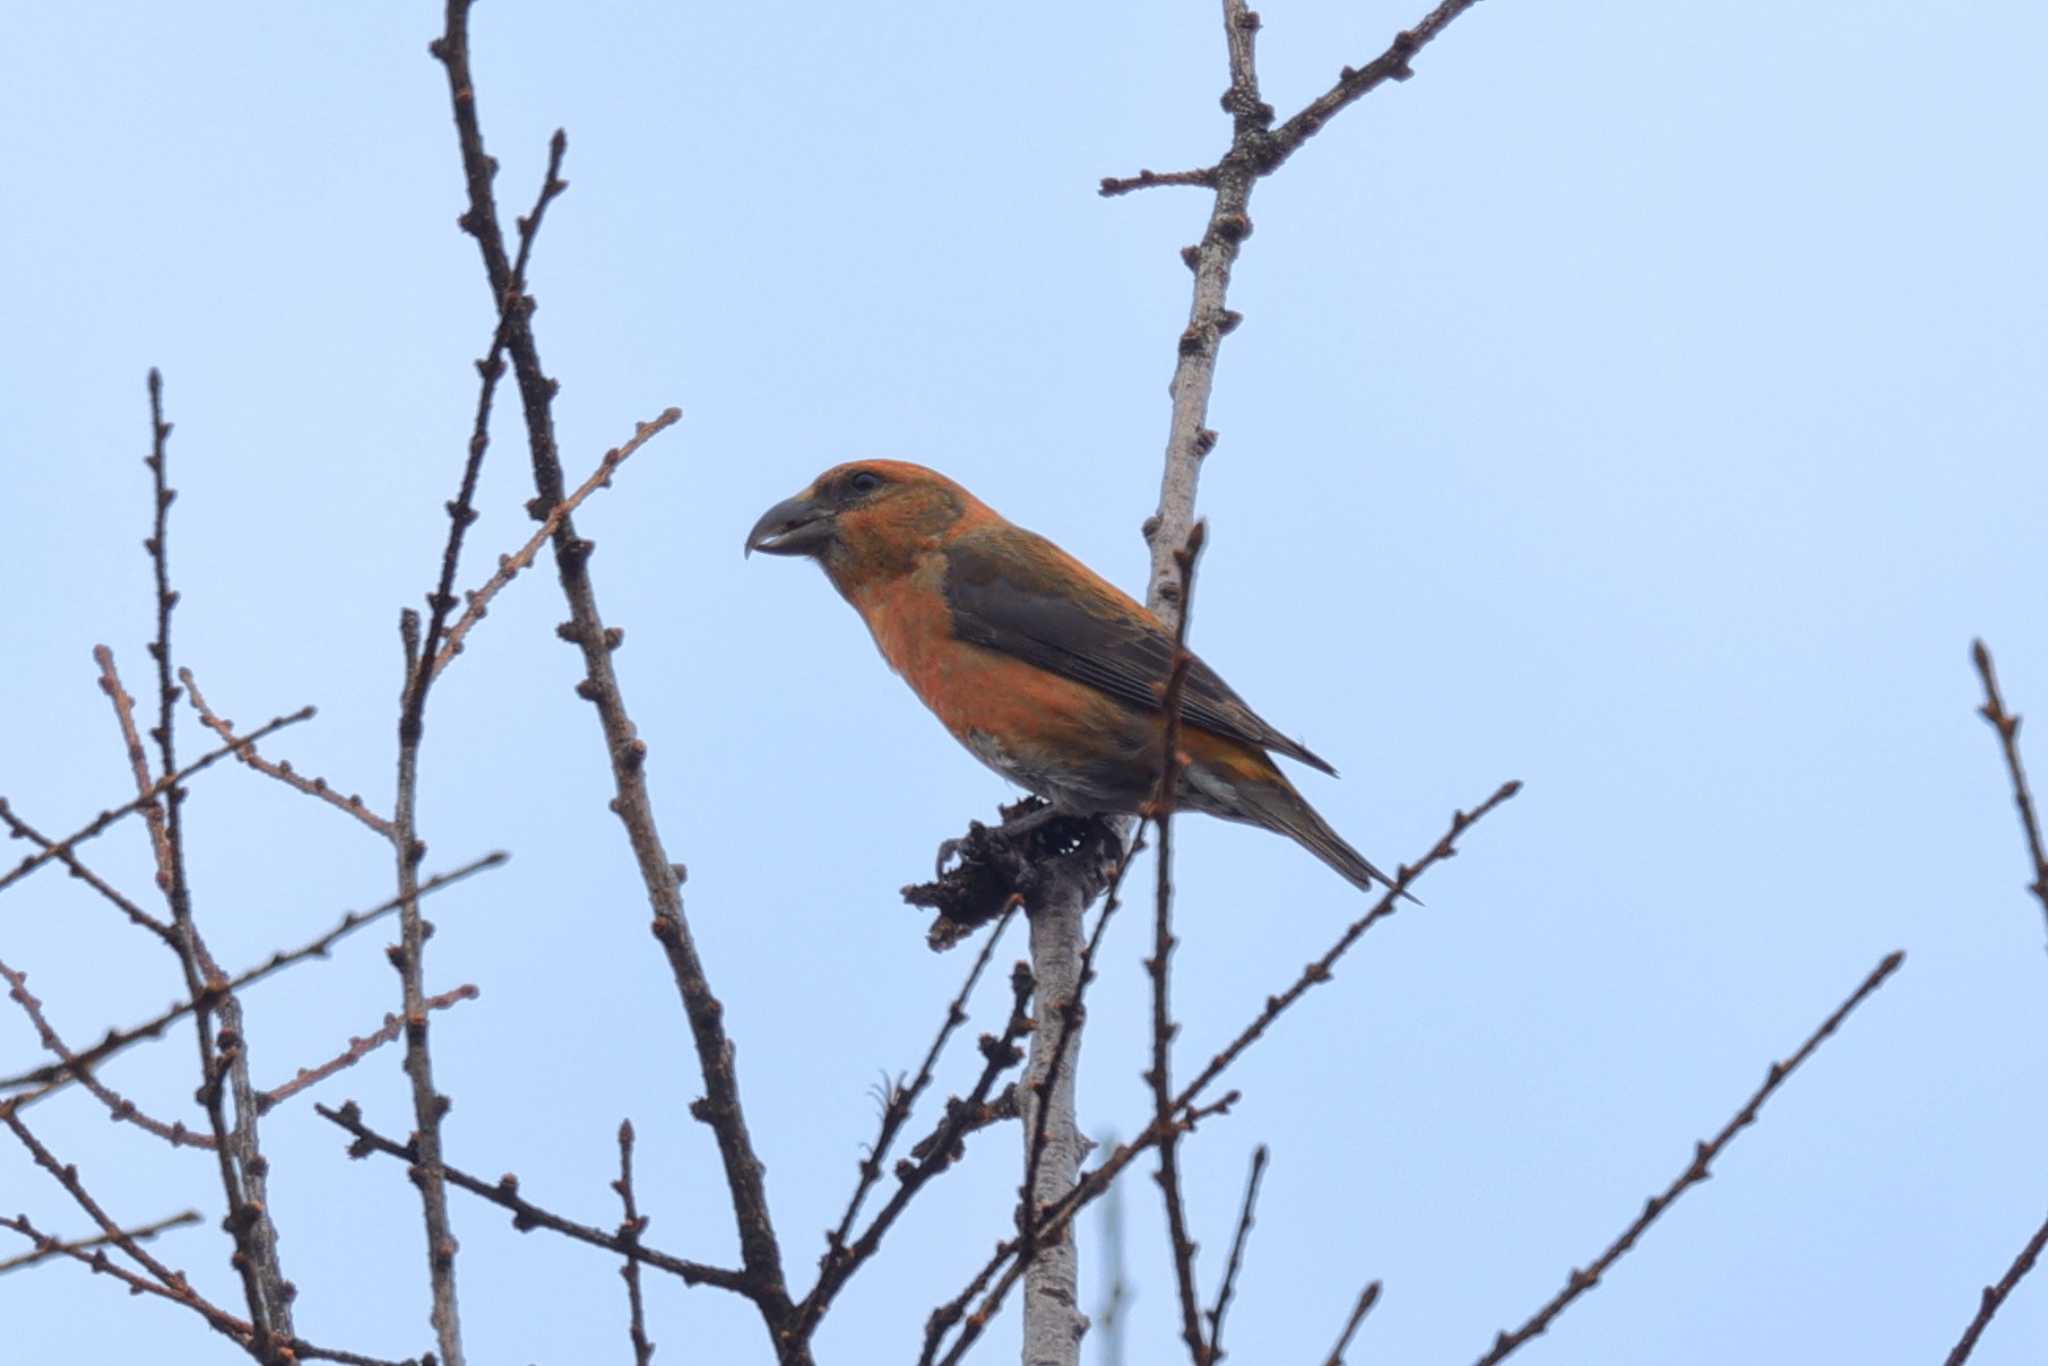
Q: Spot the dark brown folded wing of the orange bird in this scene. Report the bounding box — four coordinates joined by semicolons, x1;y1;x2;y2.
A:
944;526;1337;774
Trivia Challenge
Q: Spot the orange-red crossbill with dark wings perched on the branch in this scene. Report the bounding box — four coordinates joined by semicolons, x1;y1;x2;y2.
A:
748;461;1391;889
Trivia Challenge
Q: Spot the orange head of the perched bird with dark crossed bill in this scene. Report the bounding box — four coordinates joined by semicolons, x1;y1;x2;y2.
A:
745;461;985;590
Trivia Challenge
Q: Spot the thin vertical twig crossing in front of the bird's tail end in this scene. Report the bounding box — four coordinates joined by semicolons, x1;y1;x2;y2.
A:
1145;522;1214;1366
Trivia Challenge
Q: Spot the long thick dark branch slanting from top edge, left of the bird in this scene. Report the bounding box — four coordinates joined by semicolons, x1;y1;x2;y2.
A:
432;0;811;1366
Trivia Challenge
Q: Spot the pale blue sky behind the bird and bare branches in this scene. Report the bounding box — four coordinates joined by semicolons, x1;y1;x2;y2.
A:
0;0;2048;1366
